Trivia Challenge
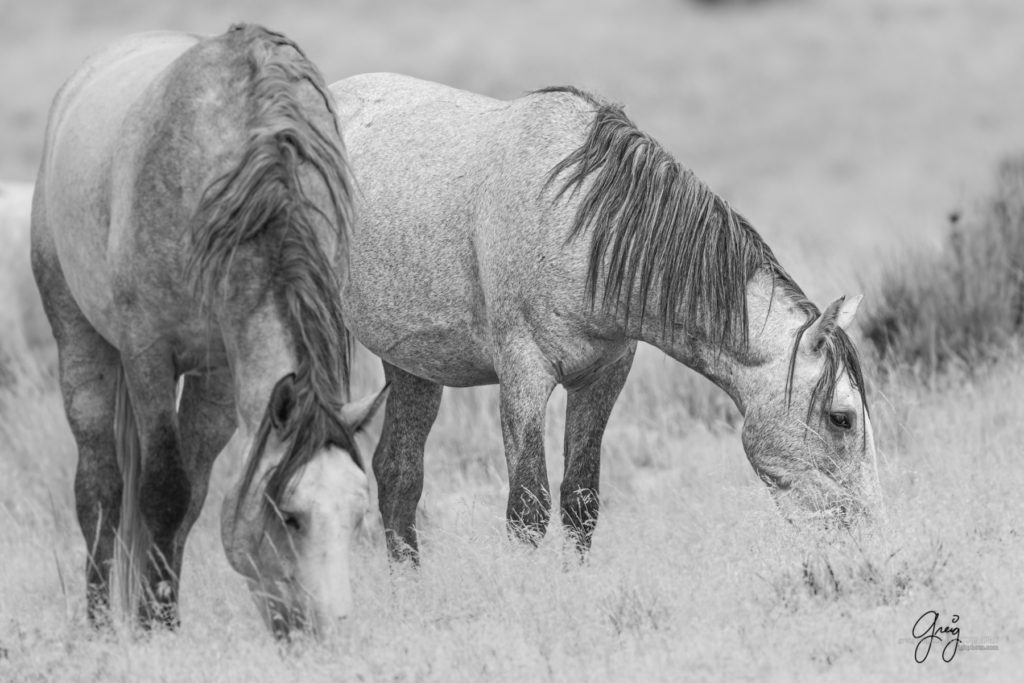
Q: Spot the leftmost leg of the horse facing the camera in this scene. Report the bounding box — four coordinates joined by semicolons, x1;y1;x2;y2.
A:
33;246;123;627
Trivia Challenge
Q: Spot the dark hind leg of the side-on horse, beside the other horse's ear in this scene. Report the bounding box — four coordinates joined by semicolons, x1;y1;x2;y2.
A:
373;362;443;563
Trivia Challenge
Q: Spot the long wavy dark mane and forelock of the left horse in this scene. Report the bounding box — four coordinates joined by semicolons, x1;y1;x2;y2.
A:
188;25;355;520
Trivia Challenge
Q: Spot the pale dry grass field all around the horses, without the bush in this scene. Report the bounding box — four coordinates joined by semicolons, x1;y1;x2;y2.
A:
0;0;1024;681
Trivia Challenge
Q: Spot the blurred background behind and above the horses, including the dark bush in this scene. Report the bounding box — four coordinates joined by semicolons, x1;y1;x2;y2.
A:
0;0;1024;389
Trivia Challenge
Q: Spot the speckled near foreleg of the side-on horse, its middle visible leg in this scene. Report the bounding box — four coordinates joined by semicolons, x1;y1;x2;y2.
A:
499;360;555;545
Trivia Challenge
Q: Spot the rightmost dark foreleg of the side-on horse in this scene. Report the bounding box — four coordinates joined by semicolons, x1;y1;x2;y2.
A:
560;344;636;555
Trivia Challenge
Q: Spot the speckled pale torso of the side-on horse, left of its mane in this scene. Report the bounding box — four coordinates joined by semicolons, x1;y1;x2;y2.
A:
332;74;593;385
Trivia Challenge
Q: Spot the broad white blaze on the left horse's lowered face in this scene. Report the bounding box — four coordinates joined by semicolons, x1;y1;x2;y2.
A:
282;449;370;634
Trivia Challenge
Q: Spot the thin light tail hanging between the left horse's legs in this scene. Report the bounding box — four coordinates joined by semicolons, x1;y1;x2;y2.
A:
114;366;150;620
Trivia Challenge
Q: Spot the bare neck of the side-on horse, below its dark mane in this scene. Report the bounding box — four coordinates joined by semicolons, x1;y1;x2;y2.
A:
626;270;807;414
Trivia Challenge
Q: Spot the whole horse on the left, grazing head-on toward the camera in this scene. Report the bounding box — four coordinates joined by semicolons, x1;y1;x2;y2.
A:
32;26;382;635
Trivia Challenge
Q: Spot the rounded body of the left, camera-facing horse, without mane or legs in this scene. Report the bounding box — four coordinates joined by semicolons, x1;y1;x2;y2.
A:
38;29;340;345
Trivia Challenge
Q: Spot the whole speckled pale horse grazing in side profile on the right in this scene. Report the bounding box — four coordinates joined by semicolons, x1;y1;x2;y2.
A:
331;74;880;559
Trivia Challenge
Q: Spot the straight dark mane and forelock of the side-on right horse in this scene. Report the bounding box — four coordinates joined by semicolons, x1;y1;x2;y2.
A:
538;86;866;419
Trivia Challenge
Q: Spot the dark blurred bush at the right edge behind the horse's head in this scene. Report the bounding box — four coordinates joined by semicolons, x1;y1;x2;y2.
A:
862;157;1024;374
